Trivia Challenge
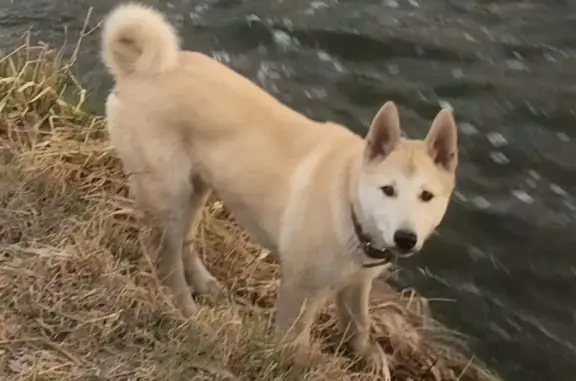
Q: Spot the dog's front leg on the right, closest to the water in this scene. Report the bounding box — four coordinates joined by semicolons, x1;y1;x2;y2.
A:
336;279;387;372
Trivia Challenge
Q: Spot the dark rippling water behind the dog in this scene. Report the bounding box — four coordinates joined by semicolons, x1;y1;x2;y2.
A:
0;0;576;381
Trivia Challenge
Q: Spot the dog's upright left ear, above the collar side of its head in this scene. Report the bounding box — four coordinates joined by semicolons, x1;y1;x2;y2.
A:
365;101;400;162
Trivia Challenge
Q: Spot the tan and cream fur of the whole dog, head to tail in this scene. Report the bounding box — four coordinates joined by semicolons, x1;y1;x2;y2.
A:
103;4;457;367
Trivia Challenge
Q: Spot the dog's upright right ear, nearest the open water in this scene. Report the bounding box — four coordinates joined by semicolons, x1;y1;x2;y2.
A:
425;108;458;172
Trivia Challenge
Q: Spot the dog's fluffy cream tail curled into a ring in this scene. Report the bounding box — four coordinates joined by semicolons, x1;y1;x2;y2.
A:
102;3;180;78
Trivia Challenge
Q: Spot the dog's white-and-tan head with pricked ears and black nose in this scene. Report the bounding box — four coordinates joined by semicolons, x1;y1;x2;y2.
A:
358;102;458;253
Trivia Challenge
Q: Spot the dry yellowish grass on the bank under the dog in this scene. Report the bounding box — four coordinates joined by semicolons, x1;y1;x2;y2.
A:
0;37;498;381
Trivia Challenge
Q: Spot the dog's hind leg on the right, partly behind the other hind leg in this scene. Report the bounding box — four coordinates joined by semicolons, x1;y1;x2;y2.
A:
182;176;225;297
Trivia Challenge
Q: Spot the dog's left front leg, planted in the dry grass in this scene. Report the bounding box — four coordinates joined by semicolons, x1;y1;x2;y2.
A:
276;277;325;344
